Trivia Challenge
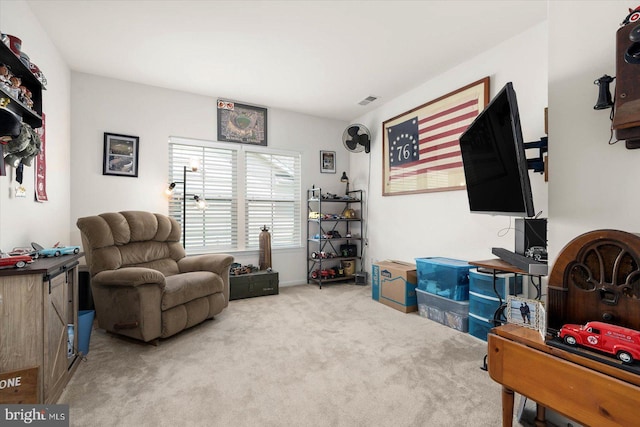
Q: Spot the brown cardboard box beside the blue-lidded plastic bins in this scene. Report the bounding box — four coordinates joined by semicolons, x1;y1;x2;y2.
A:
371;260;418;313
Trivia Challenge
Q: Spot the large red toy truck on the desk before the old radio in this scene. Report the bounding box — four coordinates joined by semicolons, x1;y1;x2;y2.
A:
558;322;640;364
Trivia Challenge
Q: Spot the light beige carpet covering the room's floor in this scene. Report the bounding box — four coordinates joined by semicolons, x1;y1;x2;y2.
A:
59;284;516;427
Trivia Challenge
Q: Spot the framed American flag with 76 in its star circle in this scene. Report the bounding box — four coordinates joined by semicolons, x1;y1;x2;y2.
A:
382;77;489;196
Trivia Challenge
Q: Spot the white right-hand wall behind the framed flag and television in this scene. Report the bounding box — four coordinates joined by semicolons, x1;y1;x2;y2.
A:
350;23;553;270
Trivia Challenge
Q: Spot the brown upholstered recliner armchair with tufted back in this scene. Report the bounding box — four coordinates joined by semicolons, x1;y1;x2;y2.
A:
76;211;233;342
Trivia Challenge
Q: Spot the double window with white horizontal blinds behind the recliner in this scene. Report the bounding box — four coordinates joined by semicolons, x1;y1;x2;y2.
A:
169;138;301;253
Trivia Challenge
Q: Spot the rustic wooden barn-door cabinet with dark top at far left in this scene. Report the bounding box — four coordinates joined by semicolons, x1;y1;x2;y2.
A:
0;253;83;404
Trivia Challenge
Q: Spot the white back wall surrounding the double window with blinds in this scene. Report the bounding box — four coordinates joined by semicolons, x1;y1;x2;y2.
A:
71;72;349;285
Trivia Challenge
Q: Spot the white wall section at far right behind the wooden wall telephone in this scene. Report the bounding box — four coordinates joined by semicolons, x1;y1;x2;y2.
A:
549;1;640;255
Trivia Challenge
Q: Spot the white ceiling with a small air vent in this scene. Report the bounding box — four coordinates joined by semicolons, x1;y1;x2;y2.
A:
27;0;547;121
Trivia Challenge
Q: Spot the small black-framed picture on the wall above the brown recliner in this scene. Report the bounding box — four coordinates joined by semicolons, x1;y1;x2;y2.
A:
102;132;140;178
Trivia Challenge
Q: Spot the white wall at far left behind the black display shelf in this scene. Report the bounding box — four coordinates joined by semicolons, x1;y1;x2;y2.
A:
0;1;71;251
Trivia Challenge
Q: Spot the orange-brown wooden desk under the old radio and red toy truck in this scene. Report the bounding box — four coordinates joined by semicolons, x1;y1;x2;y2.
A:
487;324;640;427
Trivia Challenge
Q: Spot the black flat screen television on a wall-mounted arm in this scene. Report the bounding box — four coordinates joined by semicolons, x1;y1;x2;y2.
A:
460;82;535;217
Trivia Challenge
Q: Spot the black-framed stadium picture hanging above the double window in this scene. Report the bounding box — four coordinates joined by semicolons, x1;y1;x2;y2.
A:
218;99;267;146
